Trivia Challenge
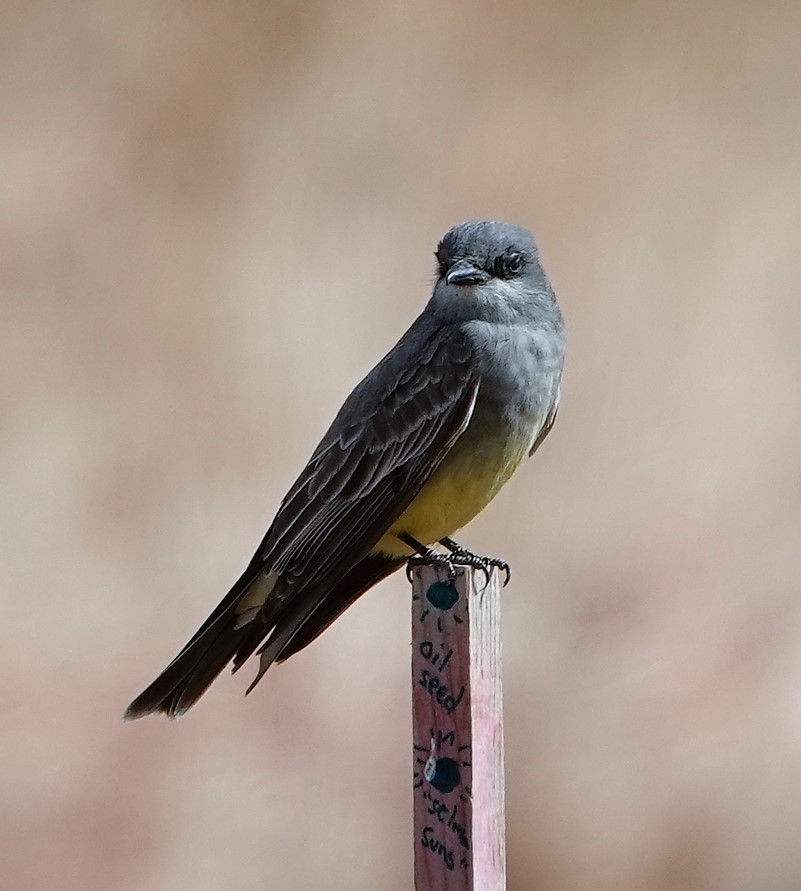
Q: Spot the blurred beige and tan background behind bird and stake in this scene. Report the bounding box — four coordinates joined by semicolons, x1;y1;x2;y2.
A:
0;0;801;891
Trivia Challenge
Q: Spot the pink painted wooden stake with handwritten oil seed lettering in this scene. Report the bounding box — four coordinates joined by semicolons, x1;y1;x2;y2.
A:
412;566;506;891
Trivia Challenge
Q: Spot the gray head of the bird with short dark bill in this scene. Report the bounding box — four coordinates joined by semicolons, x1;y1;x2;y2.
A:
431;221;558;320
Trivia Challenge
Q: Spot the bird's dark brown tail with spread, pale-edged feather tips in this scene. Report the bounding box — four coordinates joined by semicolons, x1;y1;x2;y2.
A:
125;554;403;720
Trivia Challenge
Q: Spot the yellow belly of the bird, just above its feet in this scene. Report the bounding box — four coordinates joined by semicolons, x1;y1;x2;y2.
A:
375;434;528;556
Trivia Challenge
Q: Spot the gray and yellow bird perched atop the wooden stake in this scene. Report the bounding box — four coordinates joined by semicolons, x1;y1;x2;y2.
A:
125;220;565;720
